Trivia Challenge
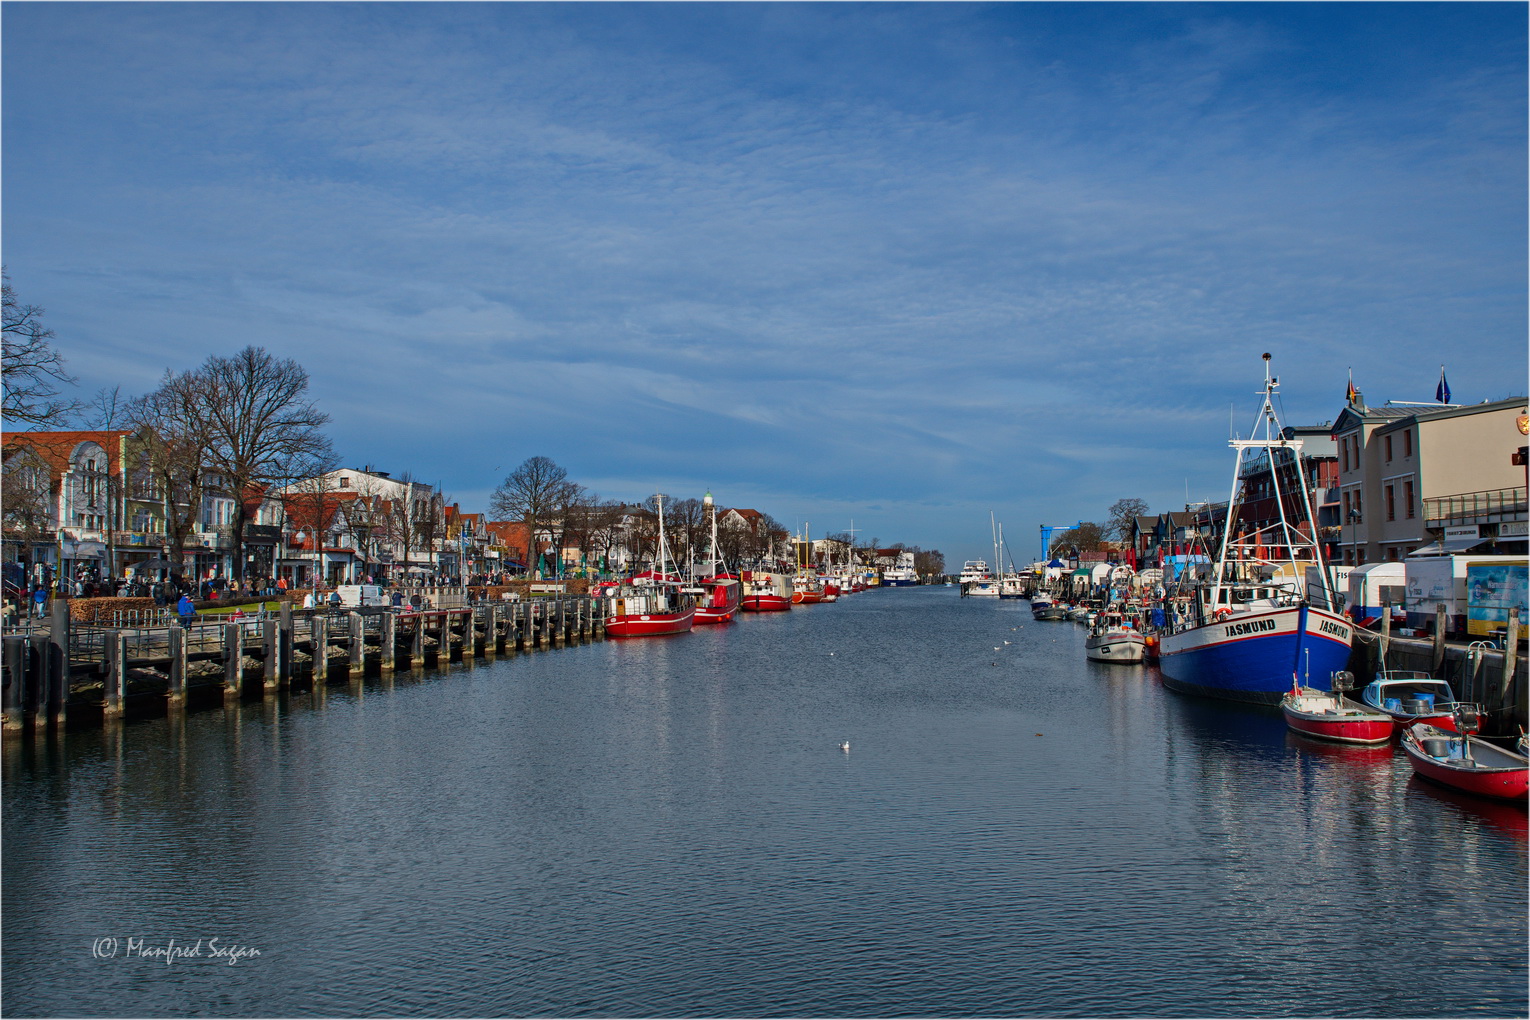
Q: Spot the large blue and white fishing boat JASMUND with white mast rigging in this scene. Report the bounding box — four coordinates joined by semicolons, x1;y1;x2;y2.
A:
1158;355;1353;705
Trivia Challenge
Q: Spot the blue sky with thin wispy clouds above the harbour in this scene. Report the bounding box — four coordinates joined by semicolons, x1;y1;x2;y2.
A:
0;3;1527;566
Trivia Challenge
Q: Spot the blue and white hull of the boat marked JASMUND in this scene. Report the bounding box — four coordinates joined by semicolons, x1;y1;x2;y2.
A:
1158;607;1353;705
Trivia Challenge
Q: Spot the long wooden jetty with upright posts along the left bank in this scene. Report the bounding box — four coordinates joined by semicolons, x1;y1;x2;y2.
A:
0;596;604;737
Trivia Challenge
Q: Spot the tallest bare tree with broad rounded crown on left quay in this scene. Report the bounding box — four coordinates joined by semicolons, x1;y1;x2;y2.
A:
185;347;330;577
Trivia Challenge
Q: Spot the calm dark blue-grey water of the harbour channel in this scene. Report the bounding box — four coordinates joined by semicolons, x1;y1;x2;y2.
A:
0;587;1527;1017
